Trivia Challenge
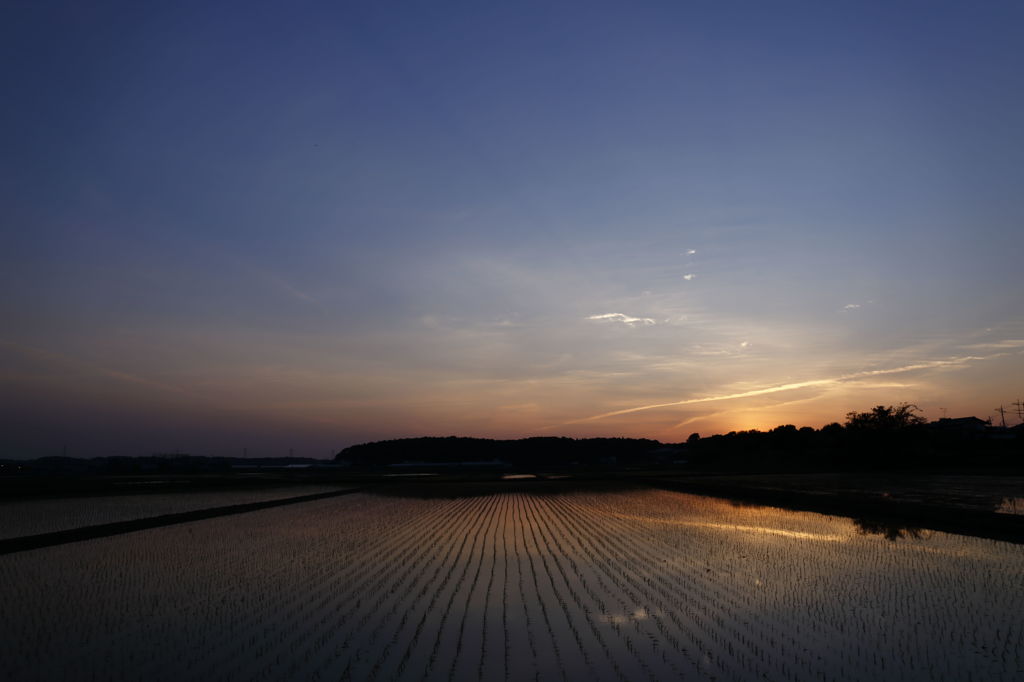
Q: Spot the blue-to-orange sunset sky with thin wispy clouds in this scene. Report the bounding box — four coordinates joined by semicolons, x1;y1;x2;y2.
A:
0;0;1024;458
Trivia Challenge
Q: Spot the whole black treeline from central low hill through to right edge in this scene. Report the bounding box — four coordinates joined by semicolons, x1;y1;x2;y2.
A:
335;406;1024;472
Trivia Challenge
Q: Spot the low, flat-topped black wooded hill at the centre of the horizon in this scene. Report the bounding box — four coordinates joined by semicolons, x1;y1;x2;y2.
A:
335;436;663;466
